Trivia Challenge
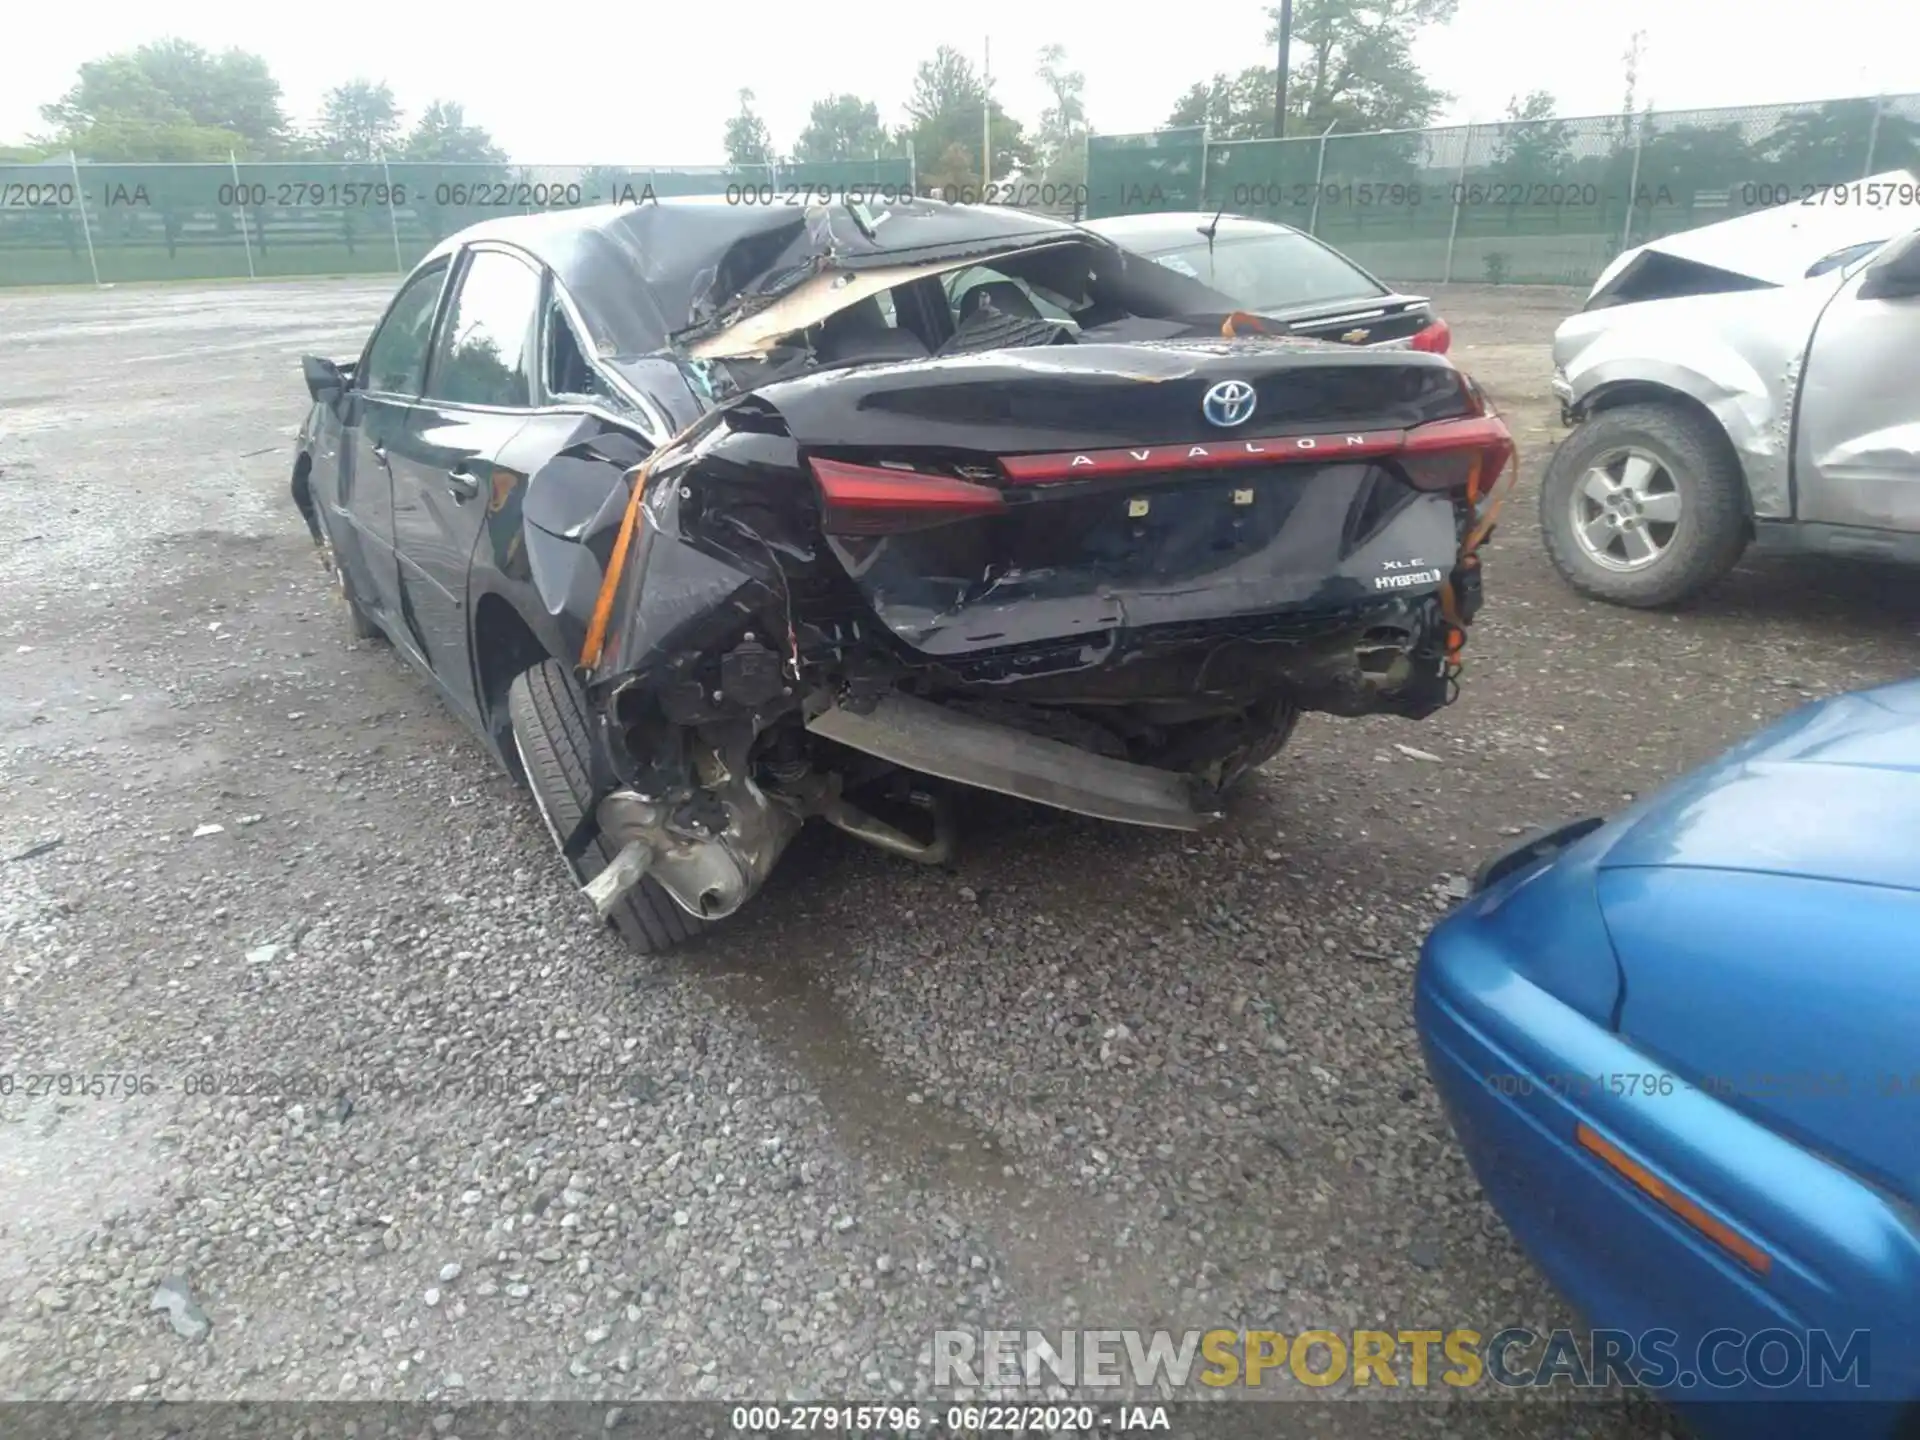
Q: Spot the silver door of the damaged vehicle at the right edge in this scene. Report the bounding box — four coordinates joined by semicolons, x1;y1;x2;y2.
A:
1793;230;1920;532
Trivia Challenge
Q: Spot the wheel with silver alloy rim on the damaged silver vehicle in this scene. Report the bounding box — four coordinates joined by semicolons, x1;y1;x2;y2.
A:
1540;405;1751;609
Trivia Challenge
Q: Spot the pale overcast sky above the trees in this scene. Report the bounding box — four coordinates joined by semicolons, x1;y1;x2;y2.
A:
0;0;1920;165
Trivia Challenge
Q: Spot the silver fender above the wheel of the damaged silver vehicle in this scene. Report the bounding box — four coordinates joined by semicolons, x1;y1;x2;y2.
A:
1553;275;1839;520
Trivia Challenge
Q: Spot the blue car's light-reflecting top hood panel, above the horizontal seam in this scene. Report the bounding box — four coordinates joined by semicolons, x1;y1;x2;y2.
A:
1599;680;1920;889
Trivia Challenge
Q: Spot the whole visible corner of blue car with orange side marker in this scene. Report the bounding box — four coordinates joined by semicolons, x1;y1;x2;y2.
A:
1415;682;1920;1440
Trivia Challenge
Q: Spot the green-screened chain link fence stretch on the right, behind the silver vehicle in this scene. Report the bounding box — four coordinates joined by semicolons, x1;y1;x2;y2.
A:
1087;94;1920;286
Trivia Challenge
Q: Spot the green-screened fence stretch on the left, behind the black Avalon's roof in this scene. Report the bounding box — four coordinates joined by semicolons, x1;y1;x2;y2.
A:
0;157;914;286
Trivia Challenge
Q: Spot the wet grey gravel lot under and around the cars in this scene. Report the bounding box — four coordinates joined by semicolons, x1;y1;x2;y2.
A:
0;282;1920;1440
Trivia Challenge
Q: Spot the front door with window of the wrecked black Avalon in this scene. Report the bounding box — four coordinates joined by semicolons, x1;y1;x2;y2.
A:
334;261;449;620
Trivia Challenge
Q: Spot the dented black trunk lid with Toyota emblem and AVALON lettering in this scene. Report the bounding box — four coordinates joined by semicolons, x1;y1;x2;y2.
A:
758;338;1505;662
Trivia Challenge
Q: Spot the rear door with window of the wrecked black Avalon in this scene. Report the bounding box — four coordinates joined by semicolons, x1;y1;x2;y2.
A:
390;246;541;716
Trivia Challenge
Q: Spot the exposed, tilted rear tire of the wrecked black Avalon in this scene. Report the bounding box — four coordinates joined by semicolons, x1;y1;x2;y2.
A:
507;660;707;954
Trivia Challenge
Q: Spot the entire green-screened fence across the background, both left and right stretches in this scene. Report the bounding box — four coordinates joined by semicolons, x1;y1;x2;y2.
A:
0;94;1920;286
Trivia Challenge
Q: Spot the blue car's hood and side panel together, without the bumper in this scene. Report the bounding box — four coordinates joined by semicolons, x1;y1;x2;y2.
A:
1596;682;1920;1204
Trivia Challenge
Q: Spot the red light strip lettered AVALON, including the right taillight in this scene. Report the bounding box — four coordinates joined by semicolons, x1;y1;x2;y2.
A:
1000;415;1513;486
